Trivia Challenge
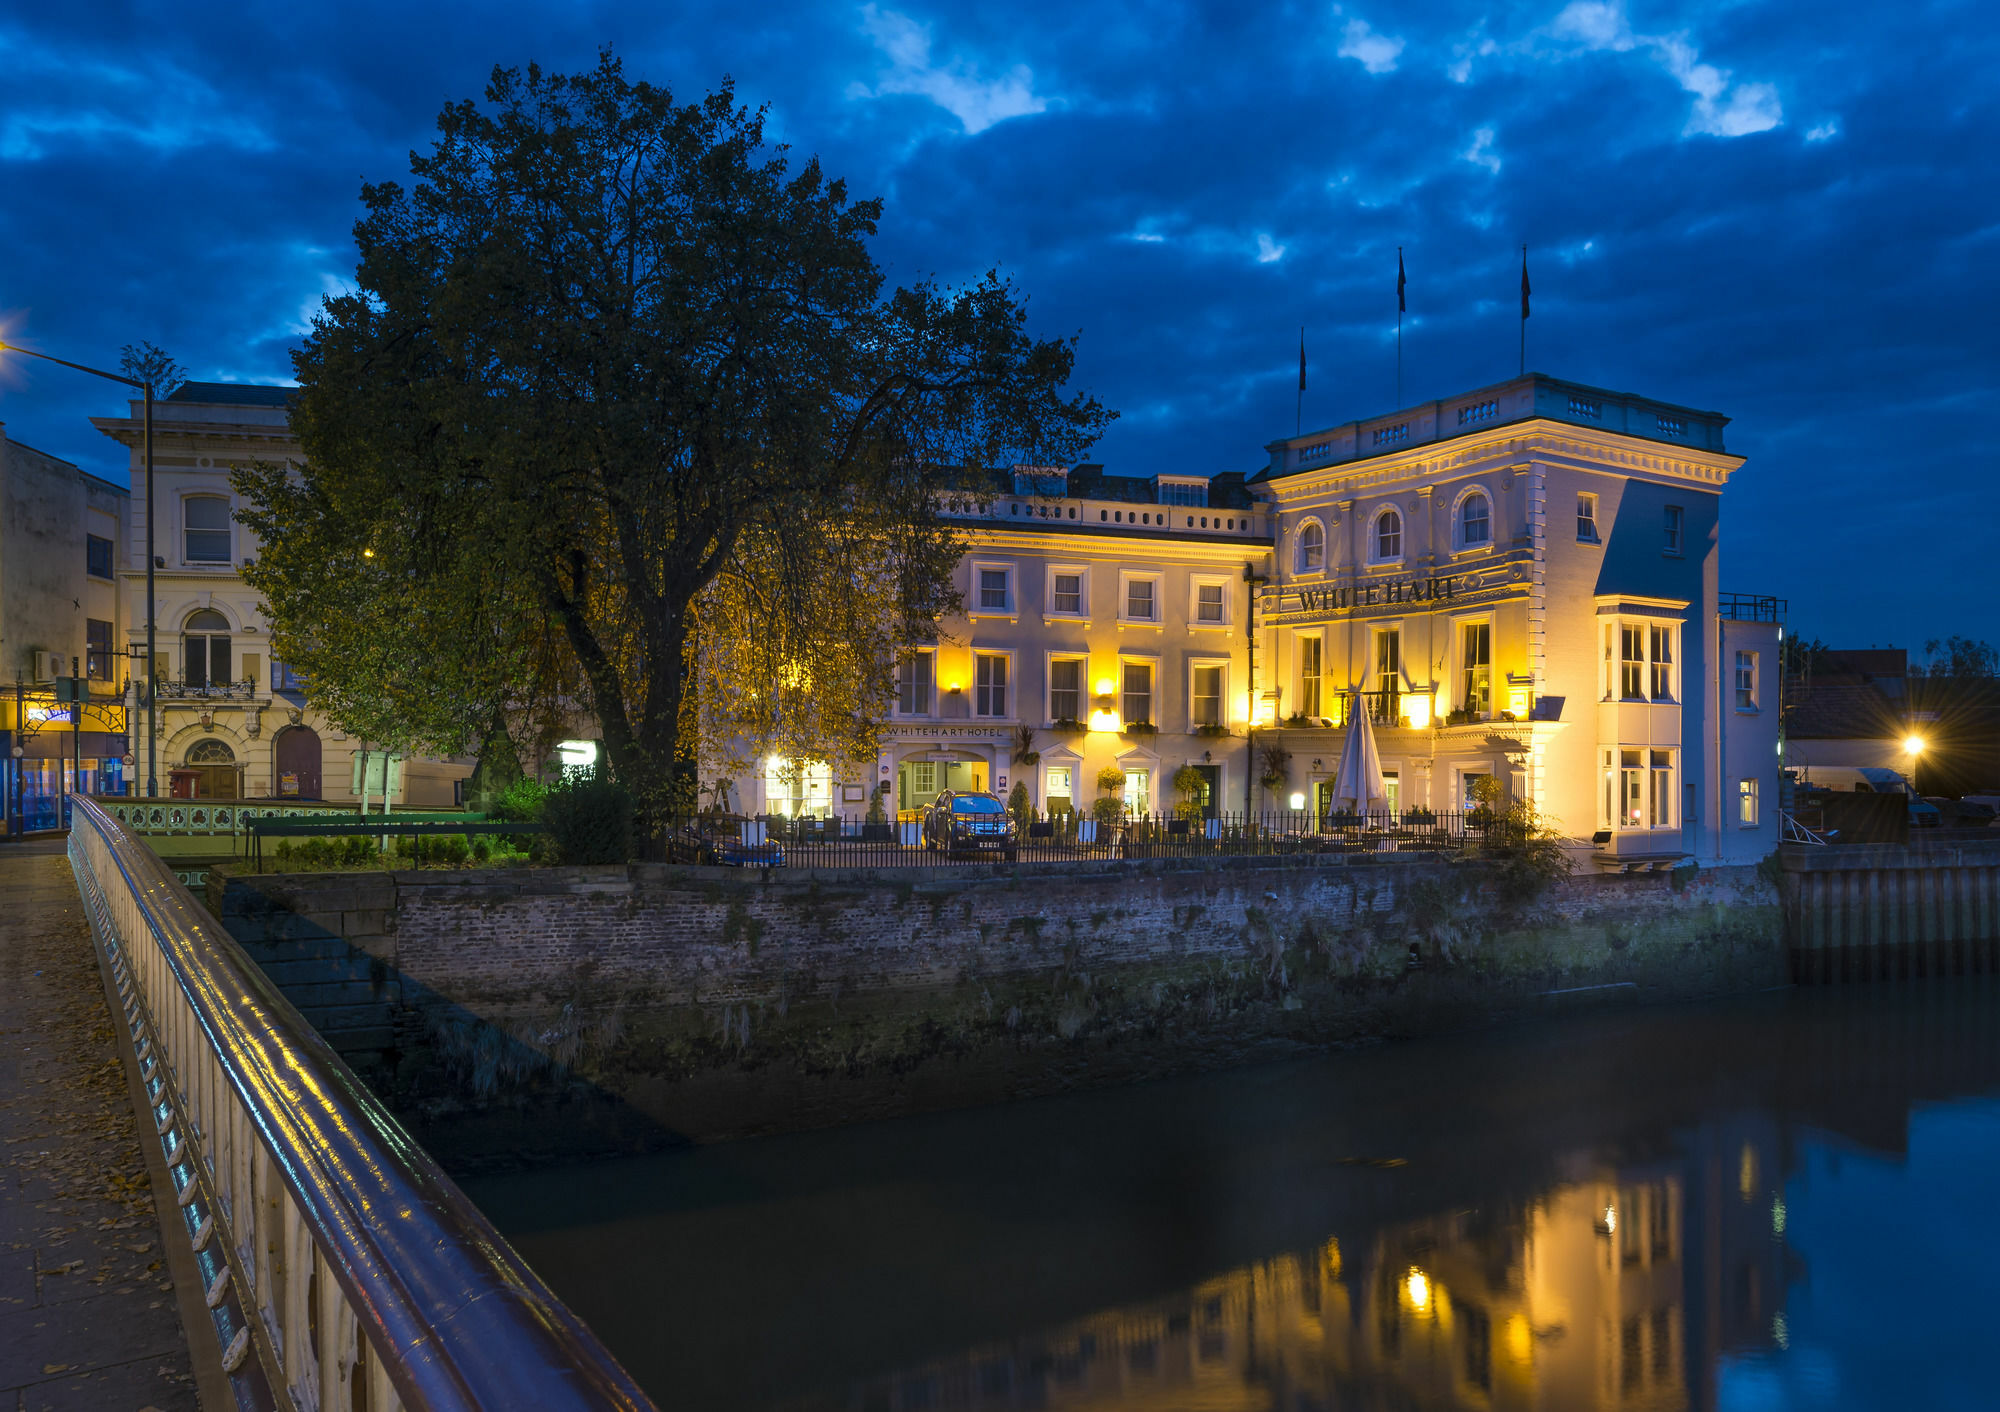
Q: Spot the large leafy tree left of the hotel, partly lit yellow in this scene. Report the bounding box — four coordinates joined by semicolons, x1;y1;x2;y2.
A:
240;54;1112;818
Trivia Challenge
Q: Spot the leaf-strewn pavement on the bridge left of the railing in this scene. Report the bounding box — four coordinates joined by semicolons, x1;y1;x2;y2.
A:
0;838;198;1412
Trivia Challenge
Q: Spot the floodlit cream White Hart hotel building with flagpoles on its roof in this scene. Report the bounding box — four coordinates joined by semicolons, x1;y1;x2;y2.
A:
736;374;1782;868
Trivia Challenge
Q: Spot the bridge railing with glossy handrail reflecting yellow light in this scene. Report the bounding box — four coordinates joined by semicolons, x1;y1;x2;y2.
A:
70;798;652;1412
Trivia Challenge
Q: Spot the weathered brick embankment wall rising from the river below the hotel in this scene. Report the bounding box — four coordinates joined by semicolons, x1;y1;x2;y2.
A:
210;860;1786;1164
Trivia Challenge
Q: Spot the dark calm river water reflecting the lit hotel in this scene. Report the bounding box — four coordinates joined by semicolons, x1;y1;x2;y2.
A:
468;980;2000;1412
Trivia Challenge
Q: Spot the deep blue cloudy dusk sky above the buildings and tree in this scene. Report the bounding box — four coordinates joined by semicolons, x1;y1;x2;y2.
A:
0;0;2000;646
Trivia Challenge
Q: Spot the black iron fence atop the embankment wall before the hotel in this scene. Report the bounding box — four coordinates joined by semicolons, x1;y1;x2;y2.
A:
664;810;1488;868
